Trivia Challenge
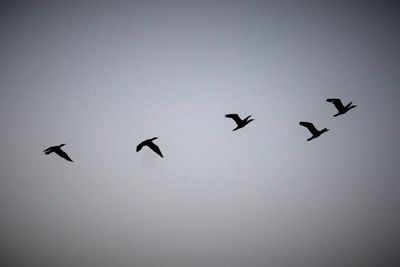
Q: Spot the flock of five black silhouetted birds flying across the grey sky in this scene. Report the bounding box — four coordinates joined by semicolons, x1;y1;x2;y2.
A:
43;98;357;162
